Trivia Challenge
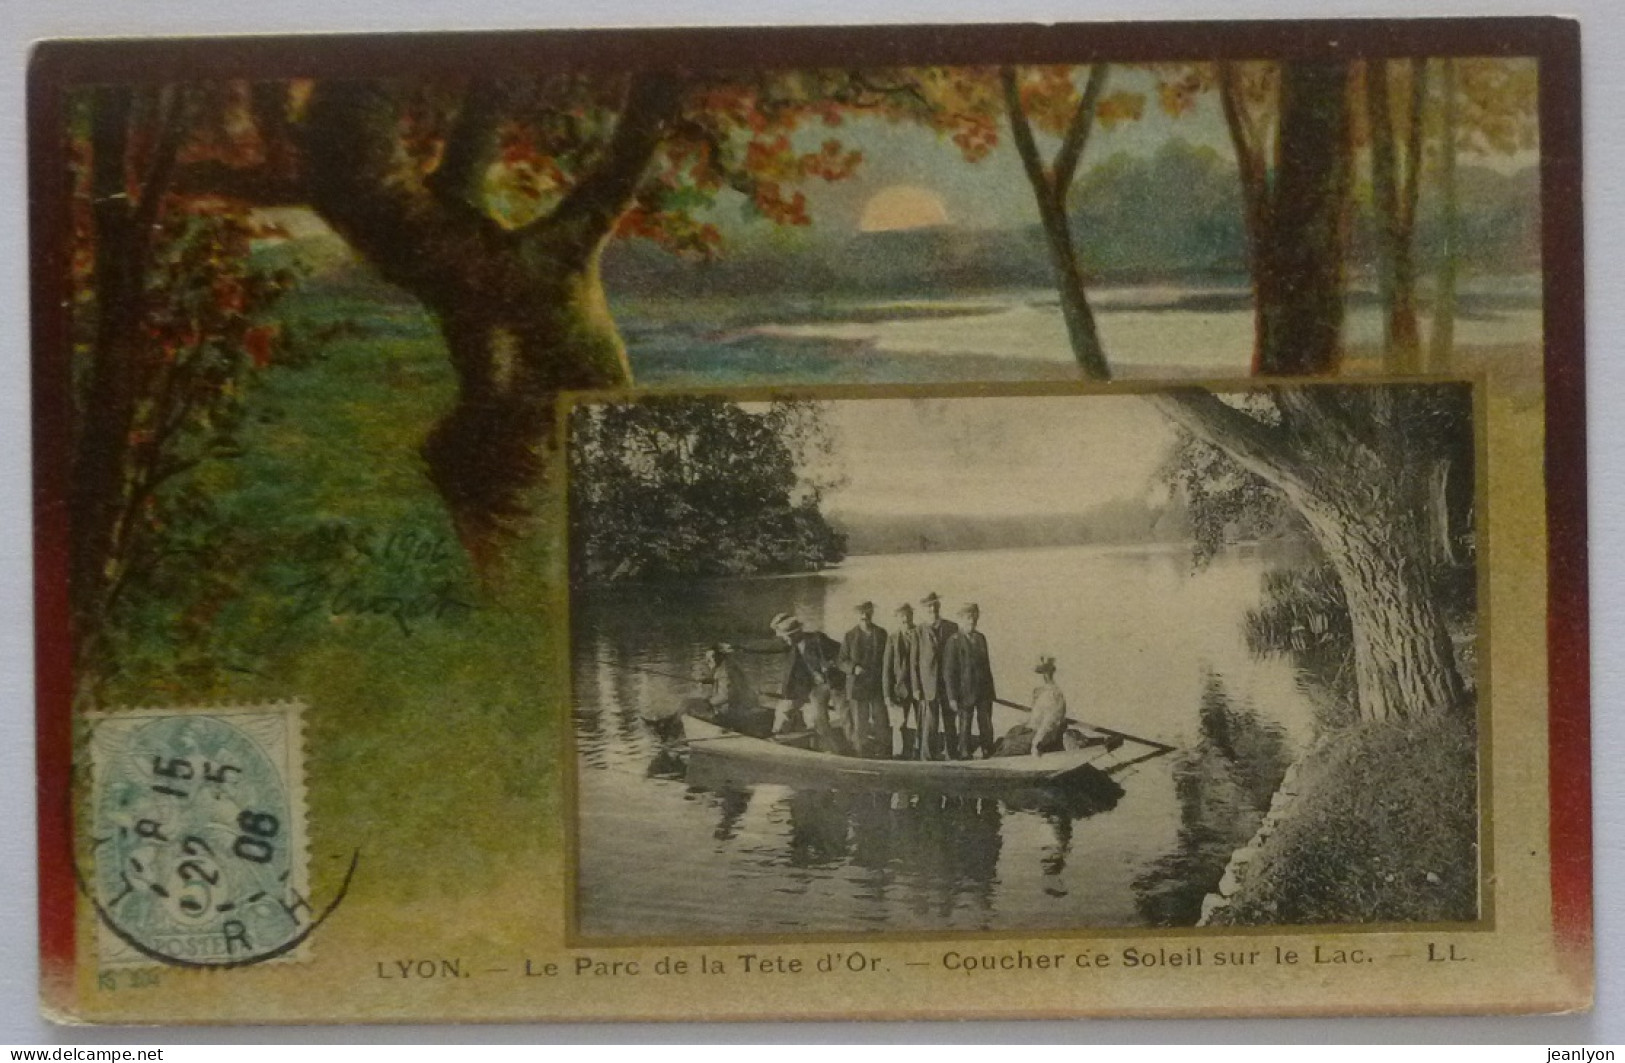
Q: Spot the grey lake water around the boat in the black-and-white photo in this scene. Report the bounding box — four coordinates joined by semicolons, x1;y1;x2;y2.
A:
572;546;1311;936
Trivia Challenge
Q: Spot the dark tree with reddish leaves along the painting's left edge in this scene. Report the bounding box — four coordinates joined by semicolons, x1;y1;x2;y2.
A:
70;89;294;692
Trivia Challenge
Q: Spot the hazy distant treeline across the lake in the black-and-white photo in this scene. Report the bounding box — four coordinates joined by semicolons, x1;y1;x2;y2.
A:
829;499;1191;554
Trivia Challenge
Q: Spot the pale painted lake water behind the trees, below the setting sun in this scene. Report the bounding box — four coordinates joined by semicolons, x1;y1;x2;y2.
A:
616;276;1542;384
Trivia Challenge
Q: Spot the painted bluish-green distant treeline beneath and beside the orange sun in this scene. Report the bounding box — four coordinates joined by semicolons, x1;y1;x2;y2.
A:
605;140;1541;296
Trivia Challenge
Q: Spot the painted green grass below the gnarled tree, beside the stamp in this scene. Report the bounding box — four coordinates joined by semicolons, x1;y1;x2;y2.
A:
102;287;567;902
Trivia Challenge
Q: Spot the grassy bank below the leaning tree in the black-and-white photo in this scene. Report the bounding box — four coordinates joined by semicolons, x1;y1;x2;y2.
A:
1214;709;1479;925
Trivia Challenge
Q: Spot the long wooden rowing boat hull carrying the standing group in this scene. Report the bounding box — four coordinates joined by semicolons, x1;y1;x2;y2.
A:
683;717;1137;793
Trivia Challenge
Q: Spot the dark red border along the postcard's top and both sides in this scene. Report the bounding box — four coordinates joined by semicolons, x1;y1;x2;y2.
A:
28;18;1593;1014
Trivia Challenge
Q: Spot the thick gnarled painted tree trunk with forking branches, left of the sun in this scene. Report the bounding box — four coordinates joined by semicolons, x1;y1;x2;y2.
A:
304;75;681;574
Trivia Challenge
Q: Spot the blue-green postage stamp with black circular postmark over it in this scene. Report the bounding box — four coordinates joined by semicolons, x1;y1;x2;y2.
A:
88;709;354;967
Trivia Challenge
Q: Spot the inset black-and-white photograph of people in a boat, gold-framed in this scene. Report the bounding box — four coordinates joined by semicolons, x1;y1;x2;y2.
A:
564;382;1484;939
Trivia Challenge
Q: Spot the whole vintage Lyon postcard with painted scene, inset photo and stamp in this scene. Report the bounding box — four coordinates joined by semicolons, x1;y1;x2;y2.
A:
29;18;1593;1024
